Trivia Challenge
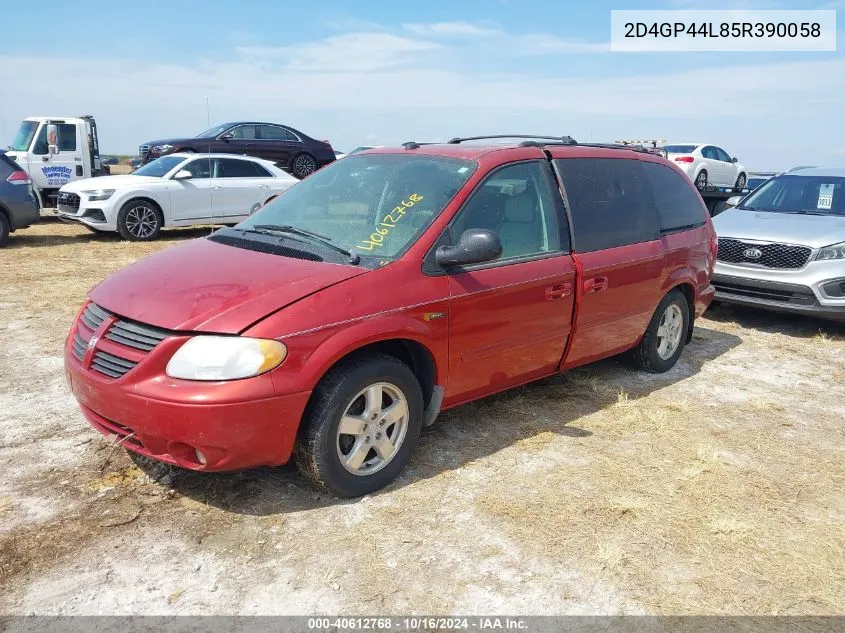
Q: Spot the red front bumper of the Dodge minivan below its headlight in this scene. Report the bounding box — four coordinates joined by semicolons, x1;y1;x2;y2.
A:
65;336;311;472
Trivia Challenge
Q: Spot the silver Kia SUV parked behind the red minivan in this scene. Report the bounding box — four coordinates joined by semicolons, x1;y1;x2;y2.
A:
713;167;845;321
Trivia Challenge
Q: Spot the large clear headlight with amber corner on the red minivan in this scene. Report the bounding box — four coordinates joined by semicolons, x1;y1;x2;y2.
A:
166;336;288;380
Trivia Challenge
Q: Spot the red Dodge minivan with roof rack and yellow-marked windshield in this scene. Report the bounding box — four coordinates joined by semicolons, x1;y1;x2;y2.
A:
65;137;716;497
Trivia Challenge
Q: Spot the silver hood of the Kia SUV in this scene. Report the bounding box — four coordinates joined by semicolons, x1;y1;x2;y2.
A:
713;208;845;248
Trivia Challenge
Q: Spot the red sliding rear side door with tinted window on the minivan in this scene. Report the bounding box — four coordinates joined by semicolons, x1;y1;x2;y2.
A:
554;158;664;369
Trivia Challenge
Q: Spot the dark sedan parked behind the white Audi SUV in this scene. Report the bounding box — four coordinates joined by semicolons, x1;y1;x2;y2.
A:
138;121;335;178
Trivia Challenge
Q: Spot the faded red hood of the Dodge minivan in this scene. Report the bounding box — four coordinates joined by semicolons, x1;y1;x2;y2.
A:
89;238;367;334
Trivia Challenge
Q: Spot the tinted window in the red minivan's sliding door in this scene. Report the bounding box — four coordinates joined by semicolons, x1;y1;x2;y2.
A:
555;158;659;253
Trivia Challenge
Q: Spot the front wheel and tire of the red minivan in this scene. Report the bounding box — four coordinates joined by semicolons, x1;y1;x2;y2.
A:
294;354;424;498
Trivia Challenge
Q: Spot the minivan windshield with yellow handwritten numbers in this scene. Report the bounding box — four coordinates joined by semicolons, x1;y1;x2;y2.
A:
236;153;477;258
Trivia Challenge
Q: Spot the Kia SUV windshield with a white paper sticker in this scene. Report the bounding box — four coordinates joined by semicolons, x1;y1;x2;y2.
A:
740;175;845;215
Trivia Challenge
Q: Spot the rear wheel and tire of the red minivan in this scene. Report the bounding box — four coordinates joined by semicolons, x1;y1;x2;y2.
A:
631;290;690;374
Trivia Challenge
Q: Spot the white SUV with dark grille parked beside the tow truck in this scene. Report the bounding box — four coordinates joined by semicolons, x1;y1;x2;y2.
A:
56;153;299;242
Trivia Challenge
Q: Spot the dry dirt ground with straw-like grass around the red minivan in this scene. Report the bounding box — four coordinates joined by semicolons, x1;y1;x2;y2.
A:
0;222;845;615
